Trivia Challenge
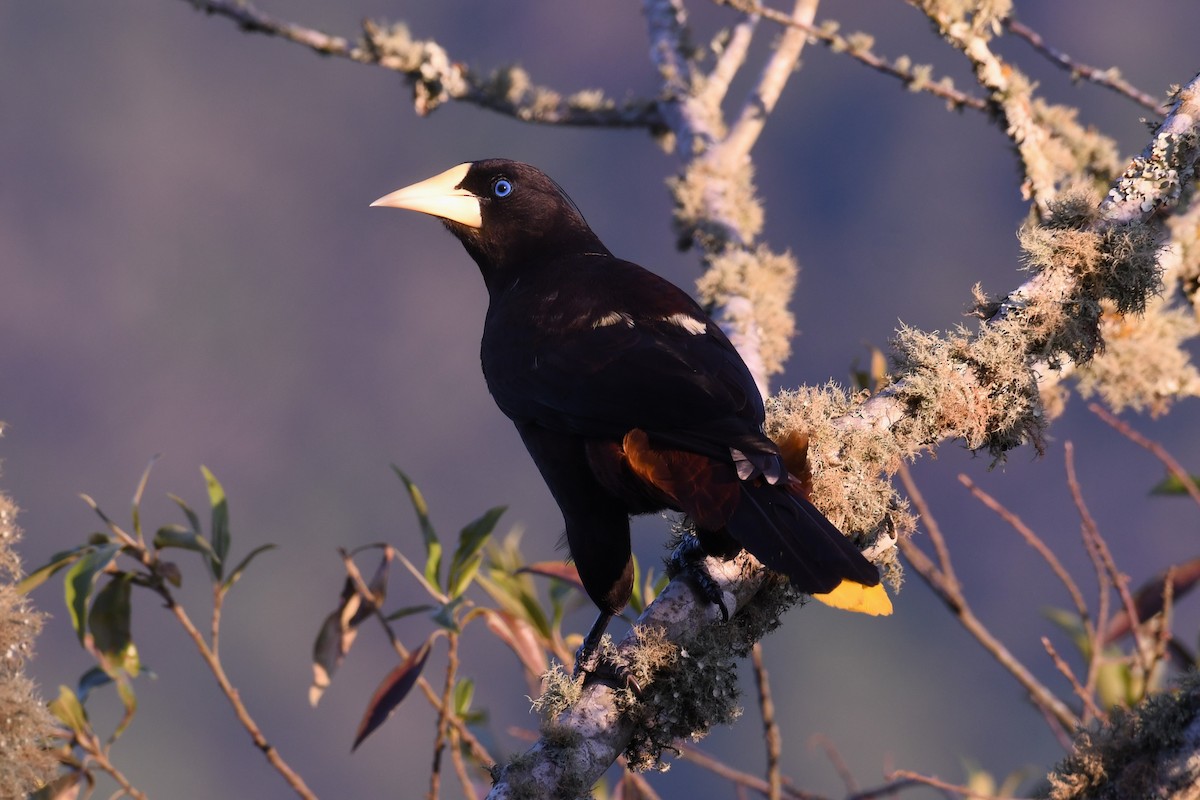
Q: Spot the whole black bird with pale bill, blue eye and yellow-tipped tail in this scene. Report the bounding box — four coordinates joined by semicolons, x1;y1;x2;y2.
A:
371;160;890;670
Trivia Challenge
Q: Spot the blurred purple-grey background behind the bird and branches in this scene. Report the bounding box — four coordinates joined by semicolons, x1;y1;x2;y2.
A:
7;0;1200;800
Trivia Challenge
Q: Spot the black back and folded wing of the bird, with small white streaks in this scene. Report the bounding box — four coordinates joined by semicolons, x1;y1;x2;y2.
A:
482;257;776;459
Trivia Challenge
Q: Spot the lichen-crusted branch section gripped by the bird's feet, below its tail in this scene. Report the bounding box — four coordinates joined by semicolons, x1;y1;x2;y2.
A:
488;553;798;800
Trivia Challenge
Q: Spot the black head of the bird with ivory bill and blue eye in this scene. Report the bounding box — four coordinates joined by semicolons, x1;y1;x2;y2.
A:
371;158;608;290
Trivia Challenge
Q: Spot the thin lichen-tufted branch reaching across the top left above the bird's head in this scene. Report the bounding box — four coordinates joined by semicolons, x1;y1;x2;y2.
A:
187;0;664;134
